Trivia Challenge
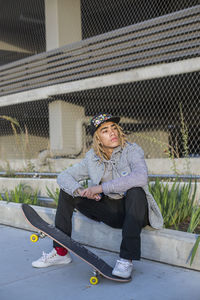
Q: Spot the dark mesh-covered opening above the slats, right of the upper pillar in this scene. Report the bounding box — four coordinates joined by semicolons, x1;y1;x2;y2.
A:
81;0;199;38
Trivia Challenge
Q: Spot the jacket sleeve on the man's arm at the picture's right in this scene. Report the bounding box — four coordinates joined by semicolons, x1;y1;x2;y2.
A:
102;144;148;195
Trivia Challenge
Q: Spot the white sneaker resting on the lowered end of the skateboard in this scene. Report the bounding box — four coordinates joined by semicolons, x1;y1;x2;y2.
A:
112;258;133;278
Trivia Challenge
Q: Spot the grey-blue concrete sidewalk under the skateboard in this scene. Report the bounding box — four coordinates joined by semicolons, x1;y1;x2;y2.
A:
0;225;200;300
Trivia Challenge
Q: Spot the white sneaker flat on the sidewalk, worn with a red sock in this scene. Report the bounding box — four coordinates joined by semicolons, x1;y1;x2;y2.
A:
32;248;72;268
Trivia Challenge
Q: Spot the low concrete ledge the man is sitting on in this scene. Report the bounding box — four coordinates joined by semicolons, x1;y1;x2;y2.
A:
0;201;200;271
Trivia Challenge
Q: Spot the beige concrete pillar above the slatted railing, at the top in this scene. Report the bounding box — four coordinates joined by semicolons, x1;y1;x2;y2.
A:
45;0;81;51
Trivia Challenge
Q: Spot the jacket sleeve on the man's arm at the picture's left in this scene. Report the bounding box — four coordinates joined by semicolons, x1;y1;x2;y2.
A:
57;154;89;196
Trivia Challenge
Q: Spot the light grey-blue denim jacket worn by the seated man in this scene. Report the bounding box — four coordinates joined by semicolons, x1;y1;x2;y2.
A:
57;143;163;229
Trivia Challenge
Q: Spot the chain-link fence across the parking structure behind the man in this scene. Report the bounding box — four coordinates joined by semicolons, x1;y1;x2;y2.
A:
0;0;200;173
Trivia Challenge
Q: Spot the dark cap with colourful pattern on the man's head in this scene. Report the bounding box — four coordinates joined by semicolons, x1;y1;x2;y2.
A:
90;113;120;136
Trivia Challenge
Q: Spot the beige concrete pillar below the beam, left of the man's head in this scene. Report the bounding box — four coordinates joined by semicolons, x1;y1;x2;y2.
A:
49;100;85;155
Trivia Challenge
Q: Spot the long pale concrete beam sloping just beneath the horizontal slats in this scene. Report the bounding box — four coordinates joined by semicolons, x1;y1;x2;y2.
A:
0;57;200;106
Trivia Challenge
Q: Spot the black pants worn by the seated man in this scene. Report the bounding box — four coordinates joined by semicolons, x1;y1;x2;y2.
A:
54;187;149;260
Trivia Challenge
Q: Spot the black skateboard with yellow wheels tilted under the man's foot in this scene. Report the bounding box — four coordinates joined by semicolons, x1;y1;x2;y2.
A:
22;204;131;284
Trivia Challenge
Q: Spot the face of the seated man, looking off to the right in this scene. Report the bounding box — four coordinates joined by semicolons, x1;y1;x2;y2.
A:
97;122;120;149
